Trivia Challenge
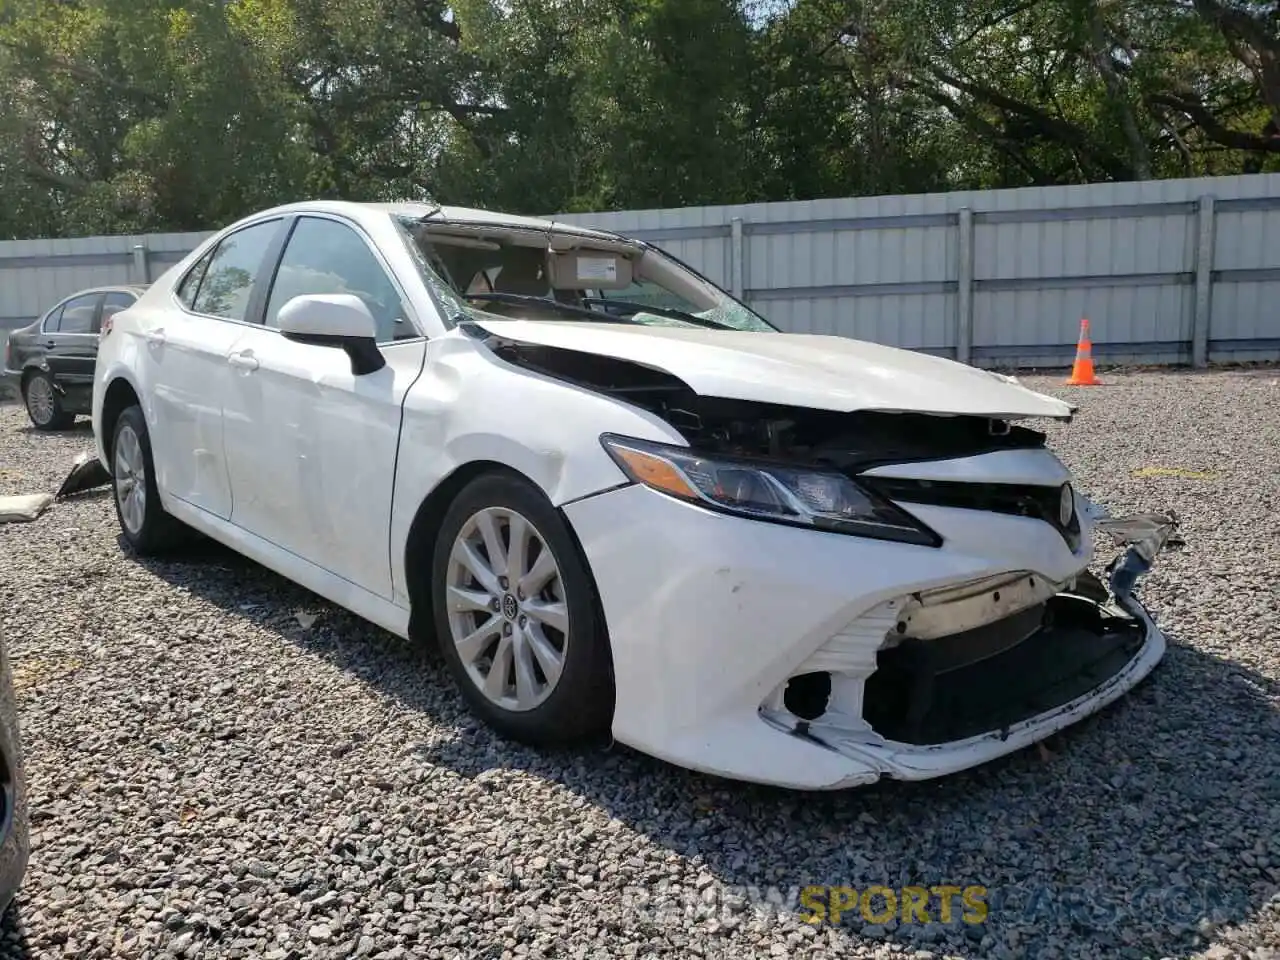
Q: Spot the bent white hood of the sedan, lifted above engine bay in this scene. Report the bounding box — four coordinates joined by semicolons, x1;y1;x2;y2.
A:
475;320;1074;420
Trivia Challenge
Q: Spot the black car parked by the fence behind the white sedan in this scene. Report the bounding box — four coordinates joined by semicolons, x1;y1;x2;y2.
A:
4;284;146;430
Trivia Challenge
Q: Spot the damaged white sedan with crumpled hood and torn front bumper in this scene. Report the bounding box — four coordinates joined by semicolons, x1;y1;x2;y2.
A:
92;202;1175;788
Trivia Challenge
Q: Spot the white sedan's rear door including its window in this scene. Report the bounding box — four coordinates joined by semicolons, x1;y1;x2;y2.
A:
140;220;284;520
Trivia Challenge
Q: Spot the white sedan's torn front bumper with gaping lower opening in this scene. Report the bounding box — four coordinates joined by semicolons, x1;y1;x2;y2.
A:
564;485;1182;790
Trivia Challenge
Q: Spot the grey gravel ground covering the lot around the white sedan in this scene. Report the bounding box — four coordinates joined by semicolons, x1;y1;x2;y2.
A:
0;370;1280;960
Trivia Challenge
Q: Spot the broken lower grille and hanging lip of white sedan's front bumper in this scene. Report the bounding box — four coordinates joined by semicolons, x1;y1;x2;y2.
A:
762;513;1180;780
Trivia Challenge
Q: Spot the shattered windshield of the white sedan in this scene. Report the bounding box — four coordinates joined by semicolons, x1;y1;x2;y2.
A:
399;218;777;332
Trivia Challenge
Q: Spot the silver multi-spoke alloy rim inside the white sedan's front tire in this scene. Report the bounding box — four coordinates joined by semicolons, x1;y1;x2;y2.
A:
445;507;570;712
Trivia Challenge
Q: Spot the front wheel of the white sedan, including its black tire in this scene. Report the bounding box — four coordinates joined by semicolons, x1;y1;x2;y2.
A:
431;474;614;746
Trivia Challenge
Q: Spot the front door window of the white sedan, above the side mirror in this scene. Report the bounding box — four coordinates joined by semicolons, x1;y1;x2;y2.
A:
266;216;420;343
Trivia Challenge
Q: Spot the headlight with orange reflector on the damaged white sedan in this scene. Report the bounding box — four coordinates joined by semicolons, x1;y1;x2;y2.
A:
600;434;942;547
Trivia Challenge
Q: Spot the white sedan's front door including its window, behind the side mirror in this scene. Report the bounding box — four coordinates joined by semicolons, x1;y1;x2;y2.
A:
223;216;426;599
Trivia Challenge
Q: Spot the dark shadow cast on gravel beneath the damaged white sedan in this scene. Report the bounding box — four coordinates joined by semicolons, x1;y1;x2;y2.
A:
135;543;1280;960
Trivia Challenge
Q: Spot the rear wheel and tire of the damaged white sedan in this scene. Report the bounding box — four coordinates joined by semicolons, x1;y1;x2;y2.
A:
111;404;187;557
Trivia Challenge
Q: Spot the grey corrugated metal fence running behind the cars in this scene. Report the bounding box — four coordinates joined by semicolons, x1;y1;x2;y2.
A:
0;174;1280;366
